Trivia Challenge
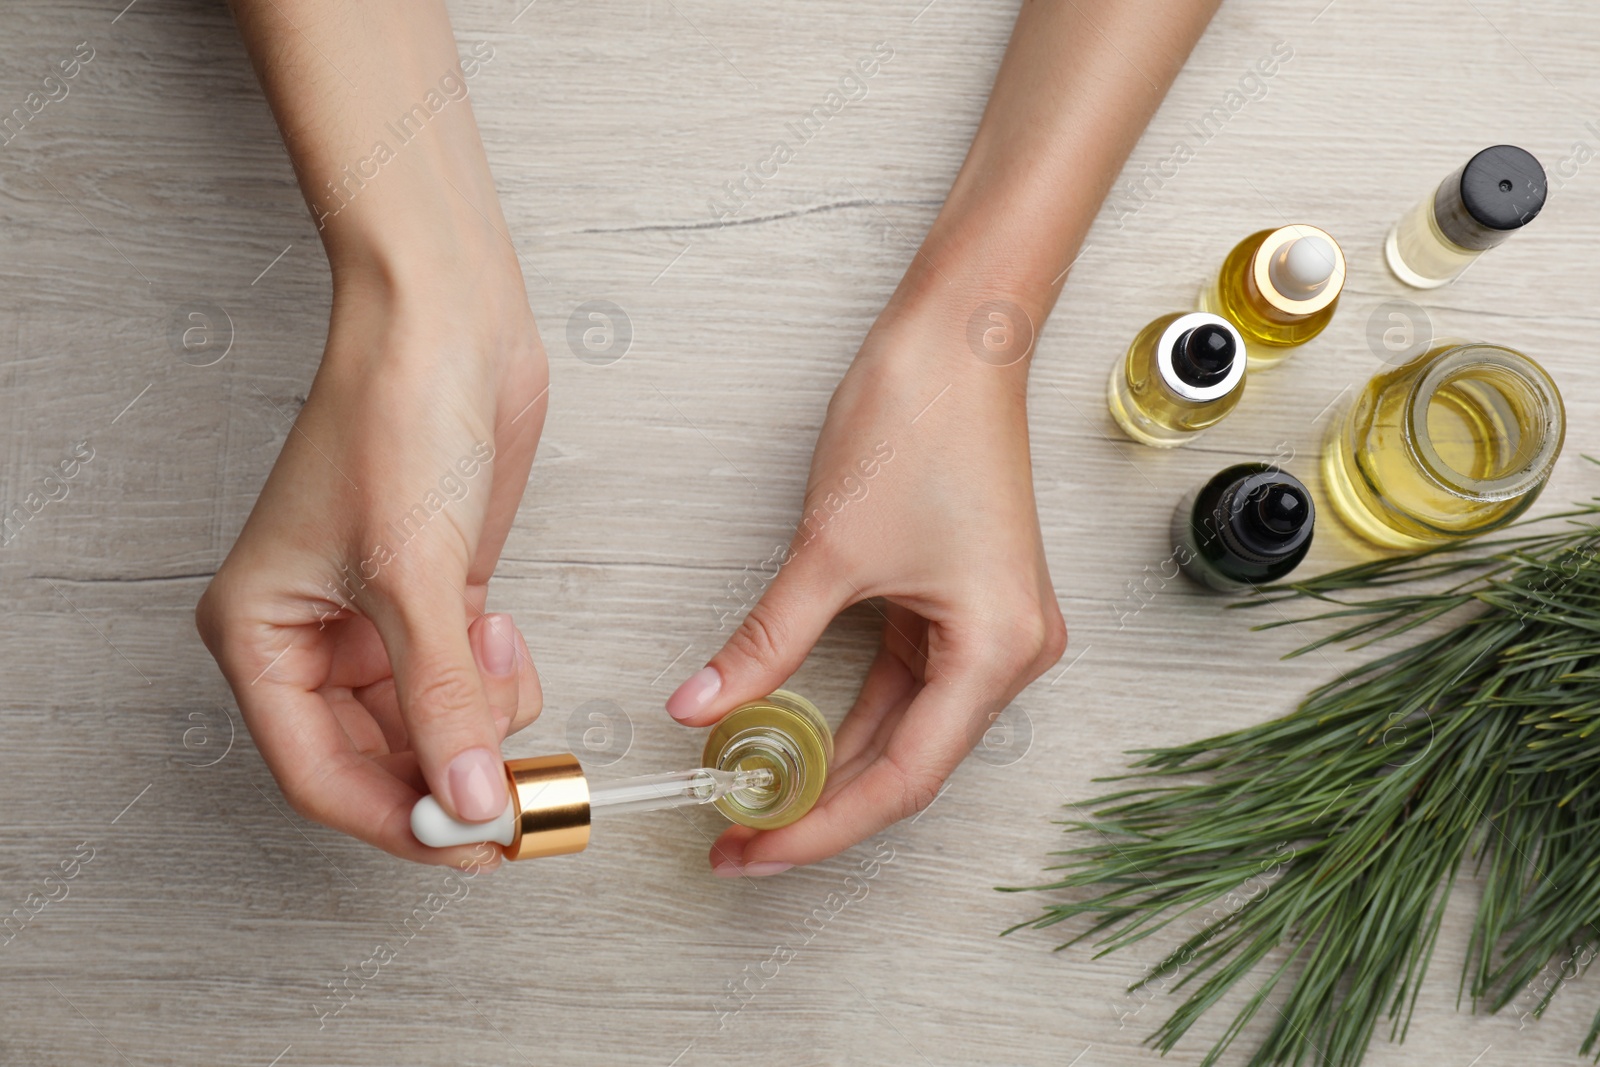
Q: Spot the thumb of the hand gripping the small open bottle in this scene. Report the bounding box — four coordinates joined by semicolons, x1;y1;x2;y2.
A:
667;561;846;726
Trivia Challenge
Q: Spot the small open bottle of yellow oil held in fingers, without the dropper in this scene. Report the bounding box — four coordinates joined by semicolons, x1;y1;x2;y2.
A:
701;689;834;830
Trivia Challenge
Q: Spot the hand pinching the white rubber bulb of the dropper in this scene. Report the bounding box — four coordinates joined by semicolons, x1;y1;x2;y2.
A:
197;248;549;865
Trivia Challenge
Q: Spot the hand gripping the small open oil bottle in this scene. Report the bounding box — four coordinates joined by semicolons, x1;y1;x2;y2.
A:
667;289;1067;877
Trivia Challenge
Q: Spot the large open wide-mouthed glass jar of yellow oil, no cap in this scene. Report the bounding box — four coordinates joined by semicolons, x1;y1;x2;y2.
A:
1322;341;1566;549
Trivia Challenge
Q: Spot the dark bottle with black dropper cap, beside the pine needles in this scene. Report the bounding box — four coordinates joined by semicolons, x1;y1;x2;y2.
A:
1173;462;1317;592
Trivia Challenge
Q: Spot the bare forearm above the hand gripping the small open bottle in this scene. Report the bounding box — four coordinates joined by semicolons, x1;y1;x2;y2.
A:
896;0;1219;325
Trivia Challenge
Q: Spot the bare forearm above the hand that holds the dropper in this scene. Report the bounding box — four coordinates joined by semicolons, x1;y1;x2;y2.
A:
232;0;515;285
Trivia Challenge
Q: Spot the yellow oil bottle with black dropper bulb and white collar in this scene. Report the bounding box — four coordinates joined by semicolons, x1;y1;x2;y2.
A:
1106;312;1245;448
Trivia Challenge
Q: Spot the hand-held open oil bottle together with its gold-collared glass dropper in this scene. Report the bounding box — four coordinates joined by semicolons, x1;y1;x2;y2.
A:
411;689;834;859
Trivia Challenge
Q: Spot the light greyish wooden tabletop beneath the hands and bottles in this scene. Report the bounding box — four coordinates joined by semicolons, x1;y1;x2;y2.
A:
0;0;1600;1067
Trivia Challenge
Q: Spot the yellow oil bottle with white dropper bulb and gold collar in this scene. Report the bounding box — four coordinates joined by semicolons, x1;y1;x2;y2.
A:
1200;224;1344;371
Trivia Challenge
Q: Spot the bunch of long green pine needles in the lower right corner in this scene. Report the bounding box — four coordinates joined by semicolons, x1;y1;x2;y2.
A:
1006;498;1600;1067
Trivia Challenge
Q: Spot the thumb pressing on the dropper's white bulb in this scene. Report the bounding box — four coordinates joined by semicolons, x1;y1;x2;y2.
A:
373;577;509;822
